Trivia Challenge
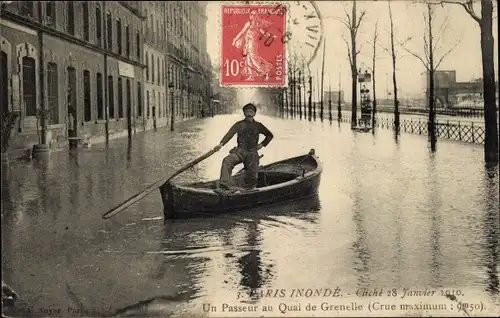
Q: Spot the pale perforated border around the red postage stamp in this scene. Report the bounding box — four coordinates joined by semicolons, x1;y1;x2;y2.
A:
217;1;290;89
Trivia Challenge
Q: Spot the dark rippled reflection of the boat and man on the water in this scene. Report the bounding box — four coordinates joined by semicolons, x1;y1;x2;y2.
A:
179;195;321;301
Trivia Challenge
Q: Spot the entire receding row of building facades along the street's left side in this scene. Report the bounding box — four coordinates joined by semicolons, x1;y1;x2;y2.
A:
0;1;213;152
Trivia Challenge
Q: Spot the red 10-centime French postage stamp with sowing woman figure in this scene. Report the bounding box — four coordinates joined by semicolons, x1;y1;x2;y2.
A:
220;5;287;87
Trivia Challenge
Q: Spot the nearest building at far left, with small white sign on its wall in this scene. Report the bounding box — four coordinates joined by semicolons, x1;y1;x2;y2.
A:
0;1;145;146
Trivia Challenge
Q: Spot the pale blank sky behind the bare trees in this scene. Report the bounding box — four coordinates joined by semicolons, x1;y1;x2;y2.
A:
207;0;498;99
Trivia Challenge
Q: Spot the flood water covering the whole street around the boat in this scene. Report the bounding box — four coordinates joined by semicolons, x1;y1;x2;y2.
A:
2;115;500;317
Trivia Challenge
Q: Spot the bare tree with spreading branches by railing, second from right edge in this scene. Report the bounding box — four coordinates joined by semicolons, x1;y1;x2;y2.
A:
405;3;459;151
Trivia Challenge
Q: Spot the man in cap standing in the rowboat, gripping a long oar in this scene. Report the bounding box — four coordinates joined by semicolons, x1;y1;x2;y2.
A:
214;103;273;191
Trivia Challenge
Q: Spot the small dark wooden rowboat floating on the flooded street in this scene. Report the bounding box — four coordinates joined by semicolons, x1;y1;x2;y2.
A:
160;149;323;219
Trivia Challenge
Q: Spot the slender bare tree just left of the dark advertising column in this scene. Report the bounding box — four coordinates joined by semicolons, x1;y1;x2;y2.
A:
339;1;366;128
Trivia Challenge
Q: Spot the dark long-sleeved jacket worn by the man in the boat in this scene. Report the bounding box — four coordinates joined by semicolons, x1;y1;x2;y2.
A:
221;119;274;150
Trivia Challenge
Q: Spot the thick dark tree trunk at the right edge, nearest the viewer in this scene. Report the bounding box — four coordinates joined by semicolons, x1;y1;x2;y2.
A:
480;0;498;164
